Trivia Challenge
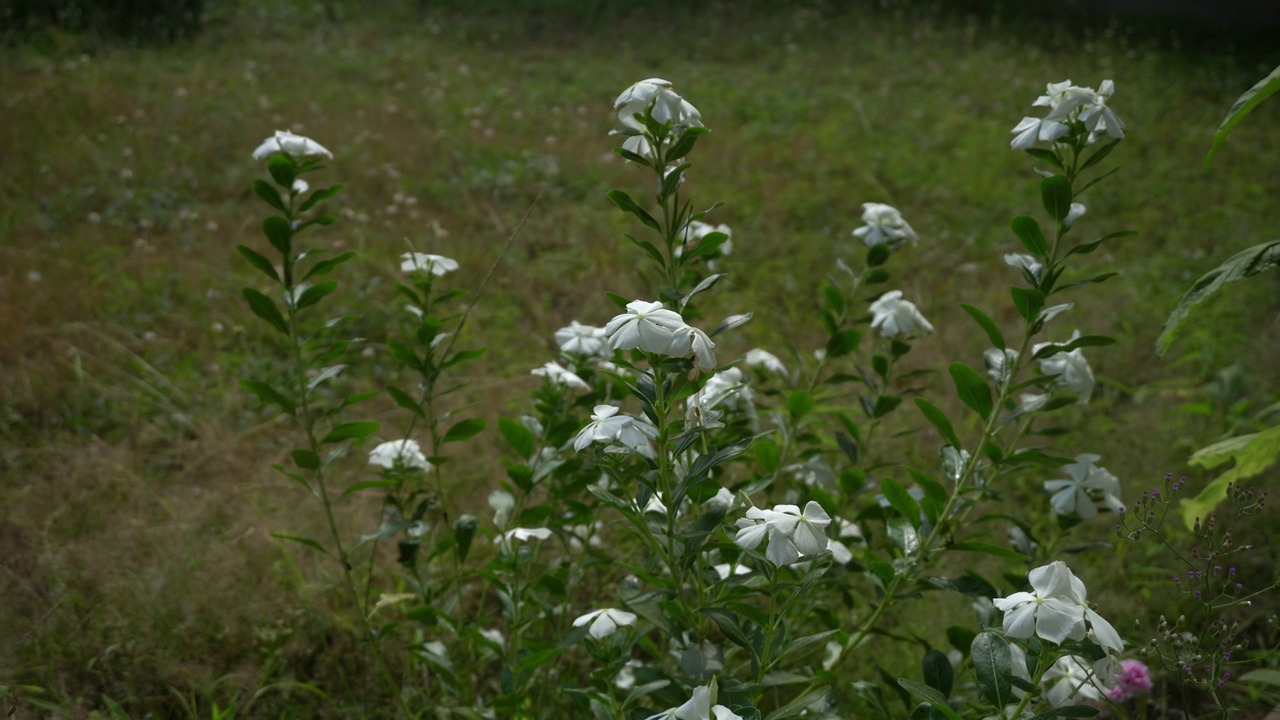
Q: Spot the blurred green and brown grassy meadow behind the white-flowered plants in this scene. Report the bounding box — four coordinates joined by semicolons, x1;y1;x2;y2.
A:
0;0;1280;717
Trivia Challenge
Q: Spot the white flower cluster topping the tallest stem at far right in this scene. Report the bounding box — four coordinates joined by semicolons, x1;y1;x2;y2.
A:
1010;79;1124;150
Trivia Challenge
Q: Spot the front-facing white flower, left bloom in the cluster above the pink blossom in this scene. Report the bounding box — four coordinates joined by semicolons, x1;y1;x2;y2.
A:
992;560;1084;643
